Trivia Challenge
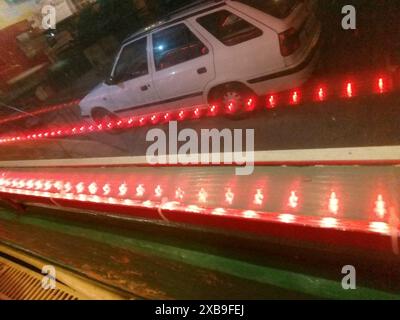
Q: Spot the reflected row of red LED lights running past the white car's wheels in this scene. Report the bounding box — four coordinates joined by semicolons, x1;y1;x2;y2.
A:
0;76;393;144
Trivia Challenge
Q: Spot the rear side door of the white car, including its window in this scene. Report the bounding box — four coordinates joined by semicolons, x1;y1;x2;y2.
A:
152;22;215;104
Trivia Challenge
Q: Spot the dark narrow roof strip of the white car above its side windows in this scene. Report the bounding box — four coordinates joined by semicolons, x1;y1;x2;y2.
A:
122;0;227;44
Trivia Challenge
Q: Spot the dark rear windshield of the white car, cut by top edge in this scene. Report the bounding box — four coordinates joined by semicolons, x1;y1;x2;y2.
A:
236;0;300;19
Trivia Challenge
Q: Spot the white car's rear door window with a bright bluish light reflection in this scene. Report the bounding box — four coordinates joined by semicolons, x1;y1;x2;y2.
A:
153;23;209;71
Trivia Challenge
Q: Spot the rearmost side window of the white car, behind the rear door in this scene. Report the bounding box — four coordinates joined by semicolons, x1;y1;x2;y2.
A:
196;10;263;46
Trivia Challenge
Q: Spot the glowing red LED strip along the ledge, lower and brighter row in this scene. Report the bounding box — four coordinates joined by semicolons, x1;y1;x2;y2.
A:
0;172;398;235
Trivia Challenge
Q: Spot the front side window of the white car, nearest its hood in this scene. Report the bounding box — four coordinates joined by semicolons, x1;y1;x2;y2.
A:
112;37;149;83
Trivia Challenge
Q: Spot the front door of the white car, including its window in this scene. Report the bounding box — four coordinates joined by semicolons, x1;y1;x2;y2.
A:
109;36;159;113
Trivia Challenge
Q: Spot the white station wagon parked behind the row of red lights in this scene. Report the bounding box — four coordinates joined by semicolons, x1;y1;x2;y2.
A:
80;0;321;121
